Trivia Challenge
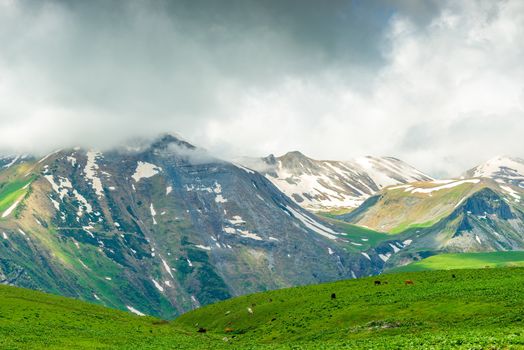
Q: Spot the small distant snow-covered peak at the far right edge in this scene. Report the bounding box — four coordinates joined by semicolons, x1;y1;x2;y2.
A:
465;156;524;187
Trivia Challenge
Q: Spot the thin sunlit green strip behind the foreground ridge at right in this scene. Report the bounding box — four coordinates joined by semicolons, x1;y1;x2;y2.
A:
389;251;524;272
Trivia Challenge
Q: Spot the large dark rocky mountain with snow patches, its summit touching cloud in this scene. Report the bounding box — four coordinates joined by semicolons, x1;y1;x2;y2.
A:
0;135;377;317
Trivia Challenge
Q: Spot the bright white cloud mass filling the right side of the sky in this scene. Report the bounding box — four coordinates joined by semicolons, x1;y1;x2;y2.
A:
200;1;524;175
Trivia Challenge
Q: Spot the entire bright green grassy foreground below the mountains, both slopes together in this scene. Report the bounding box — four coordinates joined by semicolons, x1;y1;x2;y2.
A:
0;268;524;349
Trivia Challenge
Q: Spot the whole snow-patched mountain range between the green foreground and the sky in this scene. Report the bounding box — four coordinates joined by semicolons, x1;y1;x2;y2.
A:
0;135;524;318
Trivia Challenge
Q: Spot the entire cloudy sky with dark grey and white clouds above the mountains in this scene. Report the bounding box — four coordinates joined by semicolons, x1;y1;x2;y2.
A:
0;0;524;176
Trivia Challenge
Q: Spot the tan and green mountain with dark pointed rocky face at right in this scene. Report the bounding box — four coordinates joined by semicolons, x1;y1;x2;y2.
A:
339;177;524;269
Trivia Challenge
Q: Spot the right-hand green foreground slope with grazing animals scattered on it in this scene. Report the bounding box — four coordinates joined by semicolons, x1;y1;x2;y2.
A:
175;268;524;349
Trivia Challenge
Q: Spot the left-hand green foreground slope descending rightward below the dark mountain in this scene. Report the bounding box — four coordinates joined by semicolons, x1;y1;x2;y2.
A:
0;286;213;349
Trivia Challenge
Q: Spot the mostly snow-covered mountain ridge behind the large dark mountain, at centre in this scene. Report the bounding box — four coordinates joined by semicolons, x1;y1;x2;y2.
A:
239;151;432;211
